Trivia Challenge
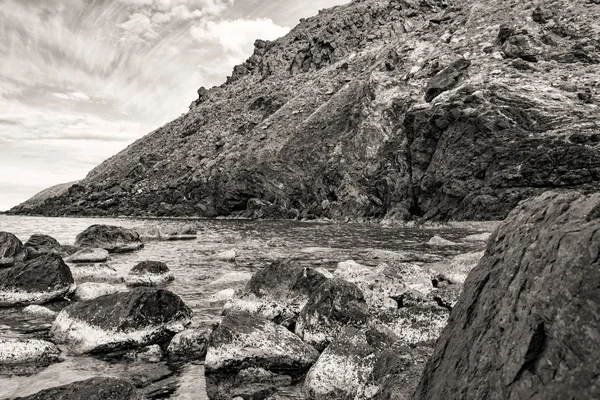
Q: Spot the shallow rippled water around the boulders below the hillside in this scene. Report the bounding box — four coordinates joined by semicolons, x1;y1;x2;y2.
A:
0;215;488;400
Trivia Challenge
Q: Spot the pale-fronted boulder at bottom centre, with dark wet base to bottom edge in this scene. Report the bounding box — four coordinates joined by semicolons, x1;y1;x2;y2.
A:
205;314;319;399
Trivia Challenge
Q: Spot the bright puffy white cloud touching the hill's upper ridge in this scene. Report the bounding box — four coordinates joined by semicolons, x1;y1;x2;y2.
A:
190;18;290;62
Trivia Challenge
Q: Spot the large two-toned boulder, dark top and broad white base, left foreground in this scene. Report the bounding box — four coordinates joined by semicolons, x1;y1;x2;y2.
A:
50;288;192;353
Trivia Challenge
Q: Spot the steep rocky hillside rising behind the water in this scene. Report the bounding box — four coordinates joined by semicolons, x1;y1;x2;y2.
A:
12;0;600;220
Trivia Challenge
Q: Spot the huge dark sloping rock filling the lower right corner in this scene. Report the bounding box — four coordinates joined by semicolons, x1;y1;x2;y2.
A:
414;192;600;399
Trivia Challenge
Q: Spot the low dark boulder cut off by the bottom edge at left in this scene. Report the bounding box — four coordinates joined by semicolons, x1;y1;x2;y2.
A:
21;377;144;400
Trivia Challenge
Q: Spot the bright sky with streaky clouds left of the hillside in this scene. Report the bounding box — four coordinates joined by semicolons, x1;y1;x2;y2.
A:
0;0;349;211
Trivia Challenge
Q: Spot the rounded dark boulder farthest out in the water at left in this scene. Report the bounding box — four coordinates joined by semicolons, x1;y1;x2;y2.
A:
75;225;144;253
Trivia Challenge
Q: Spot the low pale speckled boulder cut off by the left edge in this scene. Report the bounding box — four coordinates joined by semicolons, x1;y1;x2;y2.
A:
0;339;60;367
